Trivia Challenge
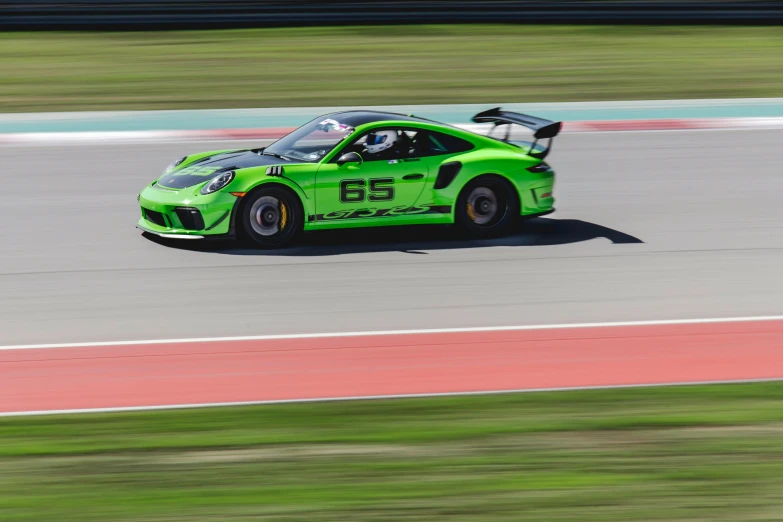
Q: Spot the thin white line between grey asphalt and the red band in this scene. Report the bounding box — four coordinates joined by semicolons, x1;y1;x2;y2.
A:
0;315;783;350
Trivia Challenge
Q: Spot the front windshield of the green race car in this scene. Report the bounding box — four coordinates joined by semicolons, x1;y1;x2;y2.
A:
264;118;354;163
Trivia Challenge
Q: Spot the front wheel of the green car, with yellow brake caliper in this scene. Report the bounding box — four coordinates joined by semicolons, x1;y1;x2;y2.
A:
241;184;304;248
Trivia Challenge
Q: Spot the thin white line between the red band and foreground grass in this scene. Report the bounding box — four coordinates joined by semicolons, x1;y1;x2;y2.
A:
0;378;783;418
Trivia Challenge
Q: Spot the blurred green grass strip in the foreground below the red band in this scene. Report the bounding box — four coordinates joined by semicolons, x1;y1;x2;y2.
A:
0;383;783;522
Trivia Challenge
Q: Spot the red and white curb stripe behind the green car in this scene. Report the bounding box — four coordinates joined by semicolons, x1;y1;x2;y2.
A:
0;117;783;145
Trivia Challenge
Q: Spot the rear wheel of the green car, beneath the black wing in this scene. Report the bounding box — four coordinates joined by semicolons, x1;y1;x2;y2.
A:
455;175;519;238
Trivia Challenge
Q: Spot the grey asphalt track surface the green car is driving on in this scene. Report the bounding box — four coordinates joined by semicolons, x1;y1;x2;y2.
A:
0;130;783;345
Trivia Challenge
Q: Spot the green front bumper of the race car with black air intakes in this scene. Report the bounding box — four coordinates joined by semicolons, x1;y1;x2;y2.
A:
136;184;240;239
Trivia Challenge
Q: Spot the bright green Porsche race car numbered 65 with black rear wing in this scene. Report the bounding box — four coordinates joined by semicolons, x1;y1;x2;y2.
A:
137;108;562;247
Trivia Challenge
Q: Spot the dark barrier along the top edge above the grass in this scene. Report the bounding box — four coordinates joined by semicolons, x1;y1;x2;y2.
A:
0;0;783;30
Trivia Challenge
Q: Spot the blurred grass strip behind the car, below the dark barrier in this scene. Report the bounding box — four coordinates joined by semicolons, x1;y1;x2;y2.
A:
0;25;783;112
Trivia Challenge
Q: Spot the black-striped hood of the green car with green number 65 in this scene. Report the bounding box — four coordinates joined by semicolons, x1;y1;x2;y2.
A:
158;150;290;189
